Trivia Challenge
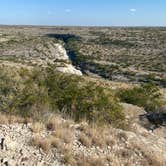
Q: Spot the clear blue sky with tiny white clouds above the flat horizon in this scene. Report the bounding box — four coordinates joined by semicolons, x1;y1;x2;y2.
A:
0;0;166;26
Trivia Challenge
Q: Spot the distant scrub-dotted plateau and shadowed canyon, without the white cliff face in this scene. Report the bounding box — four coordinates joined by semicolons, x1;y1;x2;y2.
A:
0;27;166;87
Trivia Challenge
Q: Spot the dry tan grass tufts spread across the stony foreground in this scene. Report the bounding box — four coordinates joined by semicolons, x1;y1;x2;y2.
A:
0;115;163;166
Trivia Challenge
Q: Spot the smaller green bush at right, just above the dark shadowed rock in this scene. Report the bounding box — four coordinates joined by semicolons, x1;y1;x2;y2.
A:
118;83;162;112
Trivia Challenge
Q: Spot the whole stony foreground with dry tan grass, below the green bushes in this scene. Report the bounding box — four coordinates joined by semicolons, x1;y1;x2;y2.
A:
0;104;166;166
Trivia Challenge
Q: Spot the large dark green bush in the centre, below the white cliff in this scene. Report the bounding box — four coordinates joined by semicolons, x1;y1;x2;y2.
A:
46;66;123;124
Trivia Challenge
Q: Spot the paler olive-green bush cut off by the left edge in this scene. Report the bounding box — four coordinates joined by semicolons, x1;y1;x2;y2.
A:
0;68;47;117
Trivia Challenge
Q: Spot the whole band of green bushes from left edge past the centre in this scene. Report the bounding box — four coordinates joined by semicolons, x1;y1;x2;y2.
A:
0;66;124;126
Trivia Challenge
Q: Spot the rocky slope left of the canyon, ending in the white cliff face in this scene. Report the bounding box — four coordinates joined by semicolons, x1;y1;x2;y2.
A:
0;31;82;75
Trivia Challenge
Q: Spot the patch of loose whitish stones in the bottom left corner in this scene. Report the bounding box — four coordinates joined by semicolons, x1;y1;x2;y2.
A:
0;124;60;166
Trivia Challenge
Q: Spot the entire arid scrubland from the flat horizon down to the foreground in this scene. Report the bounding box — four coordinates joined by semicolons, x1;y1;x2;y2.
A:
0;26;166;166
